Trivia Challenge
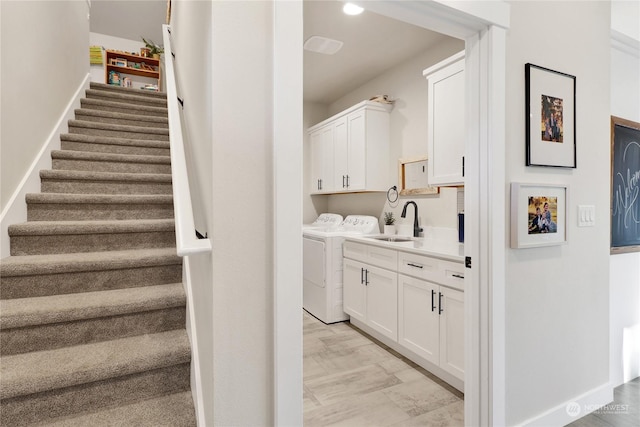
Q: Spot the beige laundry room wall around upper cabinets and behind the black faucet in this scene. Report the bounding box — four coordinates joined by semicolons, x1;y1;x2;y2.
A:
304;38;464;234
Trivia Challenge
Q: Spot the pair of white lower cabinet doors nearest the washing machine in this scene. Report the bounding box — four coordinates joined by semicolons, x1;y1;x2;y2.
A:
343;259;398;340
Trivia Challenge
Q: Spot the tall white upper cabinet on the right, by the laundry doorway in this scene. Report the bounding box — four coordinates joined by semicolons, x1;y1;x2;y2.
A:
422;52;466;186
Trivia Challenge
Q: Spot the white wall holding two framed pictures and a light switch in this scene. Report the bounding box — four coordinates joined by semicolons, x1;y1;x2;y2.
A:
504;1;610;425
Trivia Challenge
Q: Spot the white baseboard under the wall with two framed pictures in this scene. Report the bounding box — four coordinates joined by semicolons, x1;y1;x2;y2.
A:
520;383;613;427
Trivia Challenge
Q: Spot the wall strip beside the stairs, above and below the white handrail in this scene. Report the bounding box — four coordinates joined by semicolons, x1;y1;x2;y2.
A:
165;1;214;424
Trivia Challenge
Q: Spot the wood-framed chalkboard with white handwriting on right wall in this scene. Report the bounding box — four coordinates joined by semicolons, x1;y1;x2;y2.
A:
611;116;640;254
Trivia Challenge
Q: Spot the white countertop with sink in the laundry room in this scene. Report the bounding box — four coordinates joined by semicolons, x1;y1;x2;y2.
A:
345;234;464;263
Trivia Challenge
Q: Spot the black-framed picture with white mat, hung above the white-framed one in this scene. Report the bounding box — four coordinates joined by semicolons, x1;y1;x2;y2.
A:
524;64;576;168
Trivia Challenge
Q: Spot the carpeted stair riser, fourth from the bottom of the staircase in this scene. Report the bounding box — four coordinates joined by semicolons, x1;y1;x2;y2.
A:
11;230;176;256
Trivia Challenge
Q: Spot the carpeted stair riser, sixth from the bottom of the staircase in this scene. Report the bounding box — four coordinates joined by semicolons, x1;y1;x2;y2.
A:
41;179;173;195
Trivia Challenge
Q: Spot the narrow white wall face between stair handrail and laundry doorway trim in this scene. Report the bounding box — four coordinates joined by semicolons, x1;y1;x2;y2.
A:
208;1;274;426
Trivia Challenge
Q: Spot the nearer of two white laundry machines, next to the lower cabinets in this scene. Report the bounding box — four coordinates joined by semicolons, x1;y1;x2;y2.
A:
302;215;380;323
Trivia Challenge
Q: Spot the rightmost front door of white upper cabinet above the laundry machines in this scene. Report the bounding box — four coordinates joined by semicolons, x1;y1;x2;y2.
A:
347;111;367;190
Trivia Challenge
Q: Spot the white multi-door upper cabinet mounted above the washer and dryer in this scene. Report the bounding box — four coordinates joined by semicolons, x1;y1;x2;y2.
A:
308;101;392;194
